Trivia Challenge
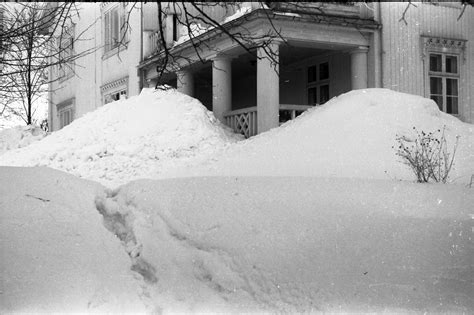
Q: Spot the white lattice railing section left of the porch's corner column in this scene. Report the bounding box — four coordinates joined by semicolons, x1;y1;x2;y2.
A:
224;106;257;138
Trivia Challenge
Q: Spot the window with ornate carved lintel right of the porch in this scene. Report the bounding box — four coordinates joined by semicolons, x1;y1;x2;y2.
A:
421;36;466;115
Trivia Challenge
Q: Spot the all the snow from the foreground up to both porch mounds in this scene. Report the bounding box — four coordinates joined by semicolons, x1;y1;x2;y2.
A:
0;89;474;313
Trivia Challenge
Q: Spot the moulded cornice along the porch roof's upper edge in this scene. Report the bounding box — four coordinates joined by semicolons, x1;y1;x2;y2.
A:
138;8;380;69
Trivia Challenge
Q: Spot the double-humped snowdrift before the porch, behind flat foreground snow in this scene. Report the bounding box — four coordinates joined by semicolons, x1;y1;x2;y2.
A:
0;89;474;187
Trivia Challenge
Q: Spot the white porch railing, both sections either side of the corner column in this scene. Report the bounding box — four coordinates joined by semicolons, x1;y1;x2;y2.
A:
224;104;313;138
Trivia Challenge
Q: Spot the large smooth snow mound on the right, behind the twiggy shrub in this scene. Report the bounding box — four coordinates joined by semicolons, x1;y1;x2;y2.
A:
170;89;474;184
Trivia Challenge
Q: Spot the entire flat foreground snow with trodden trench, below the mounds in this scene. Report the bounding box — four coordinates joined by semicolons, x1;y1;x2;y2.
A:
0;167;474;313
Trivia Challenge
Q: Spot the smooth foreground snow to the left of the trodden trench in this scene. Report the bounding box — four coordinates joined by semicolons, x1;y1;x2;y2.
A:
0;167;147;314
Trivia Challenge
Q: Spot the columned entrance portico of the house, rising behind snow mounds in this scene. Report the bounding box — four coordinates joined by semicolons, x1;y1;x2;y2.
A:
137;7;376;137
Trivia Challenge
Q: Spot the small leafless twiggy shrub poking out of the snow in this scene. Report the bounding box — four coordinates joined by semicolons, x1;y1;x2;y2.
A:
396;127;459;183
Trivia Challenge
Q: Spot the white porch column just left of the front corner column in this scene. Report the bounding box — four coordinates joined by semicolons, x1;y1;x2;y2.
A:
212;57;232;123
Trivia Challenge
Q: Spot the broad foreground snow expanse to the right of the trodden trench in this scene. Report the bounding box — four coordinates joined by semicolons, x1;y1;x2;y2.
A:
98;177;474;313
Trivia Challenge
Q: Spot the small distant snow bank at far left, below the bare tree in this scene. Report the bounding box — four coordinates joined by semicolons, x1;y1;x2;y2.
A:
0;125;47;155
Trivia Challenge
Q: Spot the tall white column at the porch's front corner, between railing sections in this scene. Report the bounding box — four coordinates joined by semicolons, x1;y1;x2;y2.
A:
257;43;280;133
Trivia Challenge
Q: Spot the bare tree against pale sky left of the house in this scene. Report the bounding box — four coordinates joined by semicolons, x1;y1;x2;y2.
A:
0;2;97;125
